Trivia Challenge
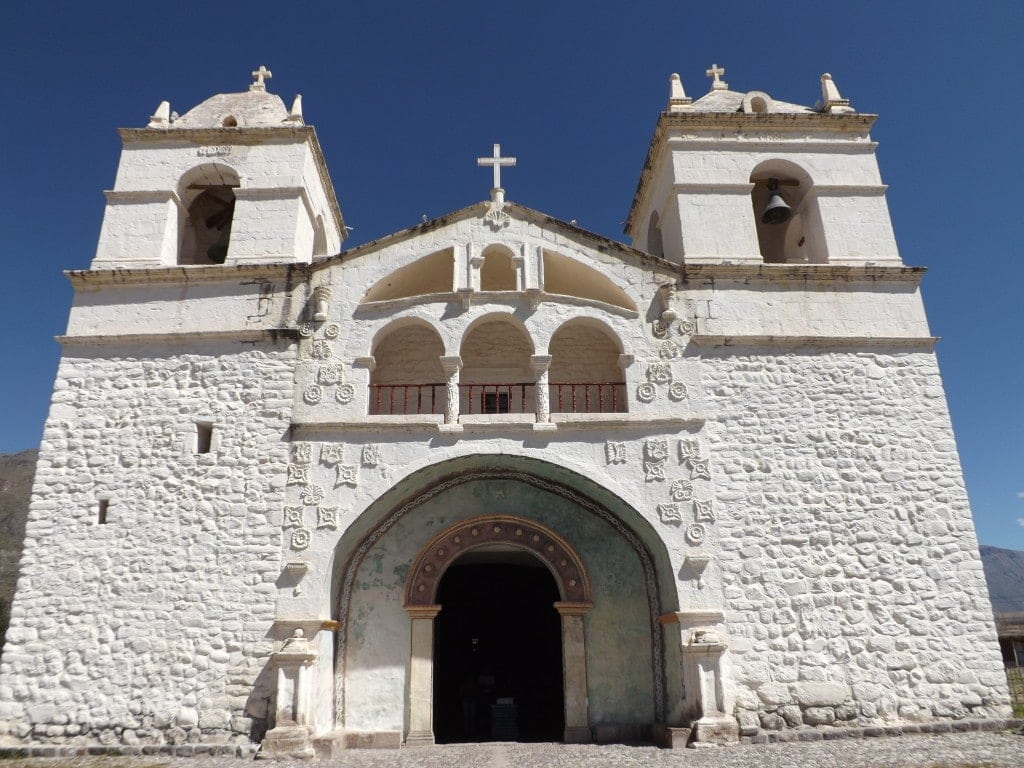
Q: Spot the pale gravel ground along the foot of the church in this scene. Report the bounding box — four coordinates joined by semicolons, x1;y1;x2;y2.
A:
3;731;1024;768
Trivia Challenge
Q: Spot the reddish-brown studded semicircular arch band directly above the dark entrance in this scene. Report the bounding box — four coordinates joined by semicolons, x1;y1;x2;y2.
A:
406;515;593;607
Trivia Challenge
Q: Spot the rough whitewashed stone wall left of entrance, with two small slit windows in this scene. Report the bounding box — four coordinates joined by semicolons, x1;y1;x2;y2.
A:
0;342;293;744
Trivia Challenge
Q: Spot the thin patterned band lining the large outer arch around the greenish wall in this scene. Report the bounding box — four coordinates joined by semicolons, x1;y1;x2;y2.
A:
335;467;666;726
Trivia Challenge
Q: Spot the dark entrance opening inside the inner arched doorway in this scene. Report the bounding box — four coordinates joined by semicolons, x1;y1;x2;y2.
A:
434;551;565;743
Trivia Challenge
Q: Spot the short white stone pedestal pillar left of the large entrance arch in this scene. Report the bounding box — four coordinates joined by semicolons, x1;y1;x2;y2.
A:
261;629;316;758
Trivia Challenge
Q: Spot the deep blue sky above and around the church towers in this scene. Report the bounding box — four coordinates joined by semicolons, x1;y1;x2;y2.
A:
0;0;1024;549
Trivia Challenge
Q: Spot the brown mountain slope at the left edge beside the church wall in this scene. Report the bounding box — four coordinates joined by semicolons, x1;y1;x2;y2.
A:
0;449;39;647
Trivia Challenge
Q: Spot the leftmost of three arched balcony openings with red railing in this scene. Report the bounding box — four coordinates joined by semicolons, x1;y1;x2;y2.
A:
369;323;445;416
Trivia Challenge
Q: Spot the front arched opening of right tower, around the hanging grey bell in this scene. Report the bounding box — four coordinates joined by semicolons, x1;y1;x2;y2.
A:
751;159;828;264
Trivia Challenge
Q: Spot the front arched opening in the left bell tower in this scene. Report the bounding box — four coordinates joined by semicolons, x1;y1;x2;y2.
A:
177;163;241;264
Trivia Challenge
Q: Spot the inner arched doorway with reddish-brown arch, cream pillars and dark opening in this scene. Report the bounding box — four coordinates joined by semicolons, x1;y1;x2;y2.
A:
406;515;593;743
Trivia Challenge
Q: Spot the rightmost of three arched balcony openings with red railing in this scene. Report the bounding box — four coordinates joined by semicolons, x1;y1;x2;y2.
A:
548;319;629;414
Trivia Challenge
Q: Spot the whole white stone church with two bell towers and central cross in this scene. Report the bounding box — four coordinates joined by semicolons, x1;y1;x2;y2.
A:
0;66;1010;756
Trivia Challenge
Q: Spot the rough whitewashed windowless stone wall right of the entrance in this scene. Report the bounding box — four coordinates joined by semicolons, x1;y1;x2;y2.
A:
702;347;1010;729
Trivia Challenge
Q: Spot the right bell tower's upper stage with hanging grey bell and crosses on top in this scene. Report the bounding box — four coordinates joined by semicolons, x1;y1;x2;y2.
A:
626;65;901;265
